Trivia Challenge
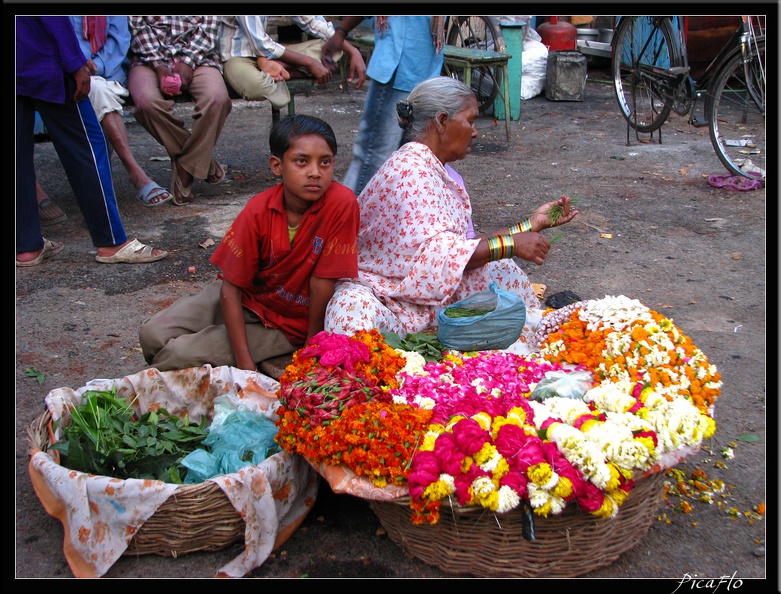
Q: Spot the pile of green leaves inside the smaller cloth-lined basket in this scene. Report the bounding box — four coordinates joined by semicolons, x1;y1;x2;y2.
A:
51;390;209;484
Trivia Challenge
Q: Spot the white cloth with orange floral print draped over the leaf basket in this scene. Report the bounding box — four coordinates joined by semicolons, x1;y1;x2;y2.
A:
29;365;318;577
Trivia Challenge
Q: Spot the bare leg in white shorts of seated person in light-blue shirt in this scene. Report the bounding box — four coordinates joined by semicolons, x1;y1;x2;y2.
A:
89;76;170;205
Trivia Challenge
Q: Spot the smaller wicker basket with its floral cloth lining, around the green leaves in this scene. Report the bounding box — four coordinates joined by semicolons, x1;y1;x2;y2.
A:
27;365;318;577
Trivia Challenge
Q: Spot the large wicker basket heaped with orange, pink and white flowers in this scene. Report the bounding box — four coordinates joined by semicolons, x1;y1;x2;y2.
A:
277;296;722;577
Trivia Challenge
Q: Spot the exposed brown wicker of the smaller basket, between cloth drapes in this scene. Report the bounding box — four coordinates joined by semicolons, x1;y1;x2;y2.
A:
27;410;246;557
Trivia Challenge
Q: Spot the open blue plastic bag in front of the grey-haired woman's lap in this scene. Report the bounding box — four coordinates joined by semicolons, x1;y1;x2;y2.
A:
437;283;526;351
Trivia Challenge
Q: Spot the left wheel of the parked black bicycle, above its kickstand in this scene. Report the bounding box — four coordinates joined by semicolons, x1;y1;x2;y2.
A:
611;16;681;132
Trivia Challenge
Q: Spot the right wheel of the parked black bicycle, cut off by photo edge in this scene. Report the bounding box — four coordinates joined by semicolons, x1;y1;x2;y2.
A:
707;38;767;181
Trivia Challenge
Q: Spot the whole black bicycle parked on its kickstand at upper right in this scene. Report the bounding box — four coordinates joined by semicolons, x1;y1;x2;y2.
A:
611;16;767;183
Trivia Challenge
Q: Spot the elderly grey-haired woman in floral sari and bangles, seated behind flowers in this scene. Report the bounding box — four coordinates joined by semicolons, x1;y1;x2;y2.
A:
325;76;577;342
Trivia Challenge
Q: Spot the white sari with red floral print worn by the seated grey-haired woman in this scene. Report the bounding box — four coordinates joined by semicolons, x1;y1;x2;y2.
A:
325;142;540;350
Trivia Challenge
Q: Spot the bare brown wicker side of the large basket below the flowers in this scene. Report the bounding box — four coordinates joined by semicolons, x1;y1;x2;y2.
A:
371;473;664;578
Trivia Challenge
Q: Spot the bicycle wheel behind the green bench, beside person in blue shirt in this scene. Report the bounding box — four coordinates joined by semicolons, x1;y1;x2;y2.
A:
444;16;505;113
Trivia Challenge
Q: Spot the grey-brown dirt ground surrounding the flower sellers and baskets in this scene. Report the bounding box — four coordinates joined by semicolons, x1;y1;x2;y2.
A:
14;65;764;580
